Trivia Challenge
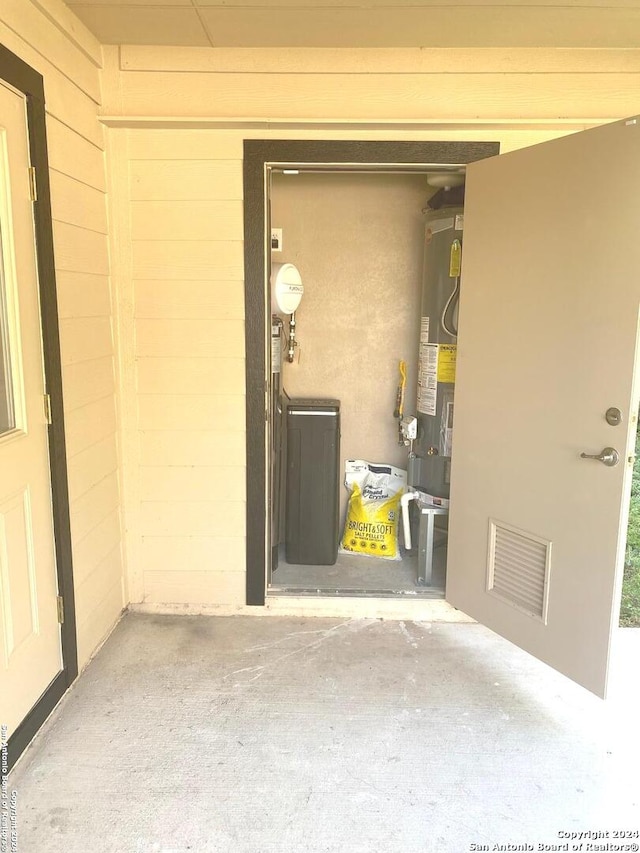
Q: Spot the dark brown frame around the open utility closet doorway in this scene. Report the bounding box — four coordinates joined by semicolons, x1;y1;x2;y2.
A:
244;139;500;606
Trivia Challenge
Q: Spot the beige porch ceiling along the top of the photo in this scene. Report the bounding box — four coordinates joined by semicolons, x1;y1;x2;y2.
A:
66;0;640;48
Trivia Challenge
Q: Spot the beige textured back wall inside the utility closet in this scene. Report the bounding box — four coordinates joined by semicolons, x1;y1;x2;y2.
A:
271;173;433;517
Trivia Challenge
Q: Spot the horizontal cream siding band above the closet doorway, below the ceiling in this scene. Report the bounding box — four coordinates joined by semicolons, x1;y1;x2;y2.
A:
103;47;640;121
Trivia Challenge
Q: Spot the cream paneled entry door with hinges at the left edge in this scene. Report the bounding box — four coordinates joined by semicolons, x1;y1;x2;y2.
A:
0;83;62;735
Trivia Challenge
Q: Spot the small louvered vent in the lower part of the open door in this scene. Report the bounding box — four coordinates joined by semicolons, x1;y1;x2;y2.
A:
487;520;551;625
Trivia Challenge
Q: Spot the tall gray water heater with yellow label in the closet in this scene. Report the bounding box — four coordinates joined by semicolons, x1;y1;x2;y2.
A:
408;202;464;498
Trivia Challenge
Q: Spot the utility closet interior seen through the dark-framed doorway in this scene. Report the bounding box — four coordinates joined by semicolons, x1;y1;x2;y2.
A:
268;166;464;598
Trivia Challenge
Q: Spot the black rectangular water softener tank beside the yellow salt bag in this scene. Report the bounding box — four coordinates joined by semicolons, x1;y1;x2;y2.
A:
285;399;340;566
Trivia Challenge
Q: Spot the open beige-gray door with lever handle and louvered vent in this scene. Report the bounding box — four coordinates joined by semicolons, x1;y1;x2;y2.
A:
447;119;640;696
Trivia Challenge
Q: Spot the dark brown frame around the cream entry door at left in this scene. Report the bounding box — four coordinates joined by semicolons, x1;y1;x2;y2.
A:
0;45;78;769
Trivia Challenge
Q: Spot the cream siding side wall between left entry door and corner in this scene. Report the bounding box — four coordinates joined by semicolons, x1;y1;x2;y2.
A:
0;0;125;667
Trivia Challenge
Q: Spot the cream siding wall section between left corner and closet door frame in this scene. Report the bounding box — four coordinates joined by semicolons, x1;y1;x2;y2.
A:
109;126;245;605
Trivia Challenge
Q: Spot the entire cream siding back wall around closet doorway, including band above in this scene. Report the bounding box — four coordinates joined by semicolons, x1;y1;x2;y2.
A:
101;47;640;608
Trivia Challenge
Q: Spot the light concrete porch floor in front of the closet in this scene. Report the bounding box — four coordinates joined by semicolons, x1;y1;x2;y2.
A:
9;614;640;853
